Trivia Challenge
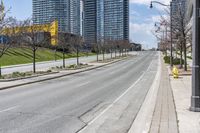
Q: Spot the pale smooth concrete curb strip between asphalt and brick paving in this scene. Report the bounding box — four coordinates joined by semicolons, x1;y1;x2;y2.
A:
128;53;161;133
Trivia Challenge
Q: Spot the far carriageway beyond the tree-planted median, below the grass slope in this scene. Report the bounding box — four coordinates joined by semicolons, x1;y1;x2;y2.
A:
2;52;117;74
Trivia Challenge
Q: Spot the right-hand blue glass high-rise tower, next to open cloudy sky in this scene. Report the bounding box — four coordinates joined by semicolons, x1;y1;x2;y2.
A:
84;0;129;43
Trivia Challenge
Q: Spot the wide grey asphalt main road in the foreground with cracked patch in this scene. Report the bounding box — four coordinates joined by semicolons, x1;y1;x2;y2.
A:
0;52;158;133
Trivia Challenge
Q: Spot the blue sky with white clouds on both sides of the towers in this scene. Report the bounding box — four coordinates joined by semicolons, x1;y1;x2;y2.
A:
4;0;170;49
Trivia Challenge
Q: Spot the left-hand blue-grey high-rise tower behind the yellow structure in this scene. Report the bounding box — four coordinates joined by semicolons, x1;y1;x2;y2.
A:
32;0;80;34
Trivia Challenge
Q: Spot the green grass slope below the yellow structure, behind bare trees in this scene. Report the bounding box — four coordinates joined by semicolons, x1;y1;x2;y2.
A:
0;48;94;66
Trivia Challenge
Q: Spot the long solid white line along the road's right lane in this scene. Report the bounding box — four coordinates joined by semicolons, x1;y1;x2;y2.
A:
78;60;153;133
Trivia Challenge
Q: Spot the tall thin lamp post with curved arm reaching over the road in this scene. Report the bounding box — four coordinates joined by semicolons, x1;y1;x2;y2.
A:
150;1;173;67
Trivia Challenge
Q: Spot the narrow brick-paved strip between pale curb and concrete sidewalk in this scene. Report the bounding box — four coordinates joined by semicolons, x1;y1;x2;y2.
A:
150;62;178;133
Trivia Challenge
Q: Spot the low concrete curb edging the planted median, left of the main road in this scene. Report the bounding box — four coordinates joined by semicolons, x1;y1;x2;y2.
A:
0;57;130;90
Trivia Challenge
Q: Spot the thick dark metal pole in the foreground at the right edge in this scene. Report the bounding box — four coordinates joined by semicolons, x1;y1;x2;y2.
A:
190;0;200;112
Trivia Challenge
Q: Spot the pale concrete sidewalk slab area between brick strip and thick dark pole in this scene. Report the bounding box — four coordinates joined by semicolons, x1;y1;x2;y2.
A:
170;76;200;133
